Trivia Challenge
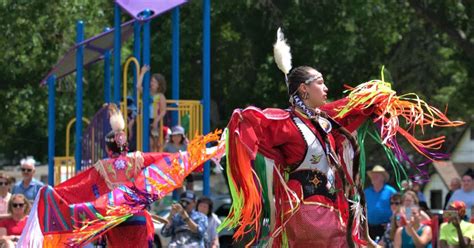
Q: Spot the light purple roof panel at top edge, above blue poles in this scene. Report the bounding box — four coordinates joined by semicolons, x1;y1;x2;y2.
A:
115;0;187;21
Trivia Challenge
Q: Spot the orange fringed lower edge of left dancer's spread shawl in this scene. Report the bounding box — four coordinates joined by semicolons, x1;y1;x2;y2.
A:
68;131;224;247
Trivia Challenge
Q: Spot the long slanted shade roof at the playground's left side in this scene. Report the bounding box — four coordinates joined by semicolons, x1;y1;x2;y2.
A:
41;19;135;84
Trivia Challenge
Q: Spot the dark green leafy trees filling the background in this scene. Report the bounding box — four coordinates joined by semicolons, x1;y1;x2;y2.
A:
0;0;474;167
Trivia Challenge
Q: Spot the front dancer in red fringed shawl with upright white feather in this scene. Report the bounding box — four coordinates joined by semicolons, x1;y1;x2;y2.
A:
220;30;462;247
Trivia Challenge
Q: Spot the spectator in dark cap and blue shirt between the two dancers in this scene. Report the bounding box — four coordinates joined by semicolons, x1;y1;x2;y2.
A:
161;191;208;248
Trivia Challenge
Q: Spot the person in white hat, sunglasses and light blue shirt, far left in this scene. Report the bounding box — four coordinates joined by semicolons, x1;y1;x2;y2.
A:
12;157;43;202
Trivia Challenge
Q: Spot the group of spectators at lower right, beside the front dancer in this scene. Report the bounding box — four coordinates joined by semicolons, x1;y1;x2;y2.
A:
365;165;474;248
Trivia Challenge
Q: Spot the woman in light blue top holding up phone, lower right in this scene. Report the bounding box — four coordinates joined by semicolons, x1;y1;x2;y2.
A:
394;205;432;248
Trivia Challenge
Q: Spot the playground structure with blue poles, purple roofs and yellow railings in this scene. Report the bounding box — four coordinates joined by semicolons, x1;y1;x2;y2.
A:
42;0;210;195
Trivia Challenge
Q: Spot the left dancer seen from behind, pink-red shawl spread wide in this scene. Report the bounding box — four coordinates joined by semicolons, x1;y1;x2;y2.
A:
19;104;223;247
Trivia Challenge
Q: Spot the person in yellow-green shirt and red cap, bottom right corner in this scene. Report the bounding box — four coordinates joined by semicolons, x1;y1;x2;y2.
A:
439;201;474;248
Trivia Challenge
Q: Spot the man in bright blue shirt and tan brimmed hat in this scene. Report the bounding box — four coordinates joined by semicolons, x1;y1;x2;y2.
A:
364;165;397;239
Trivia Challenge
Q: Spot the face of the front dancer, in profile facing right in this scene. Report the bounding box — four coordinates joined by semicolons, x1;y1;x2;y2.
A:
300;69;328;108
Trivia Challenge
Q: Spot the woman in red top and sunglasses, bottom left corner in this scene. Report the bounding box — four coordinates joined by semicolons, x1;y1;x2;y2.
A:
0;194;31;247
